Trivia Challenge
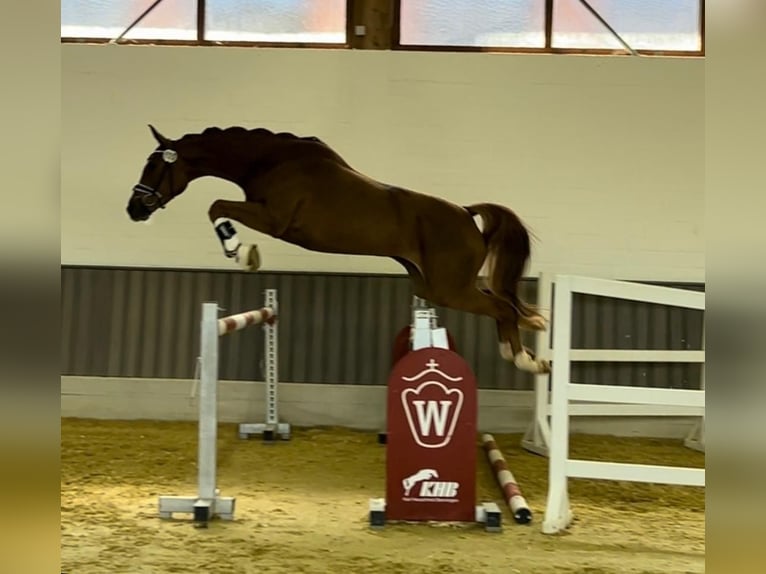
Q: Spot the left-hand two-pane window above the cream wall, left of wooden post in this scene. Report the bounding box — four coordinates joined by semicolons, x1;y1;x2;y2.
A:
61;0;347;44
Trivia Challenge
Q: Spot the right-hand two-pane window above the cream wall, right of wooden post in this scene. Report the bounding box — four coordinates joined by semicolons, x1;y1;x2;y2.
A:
399;0;704;54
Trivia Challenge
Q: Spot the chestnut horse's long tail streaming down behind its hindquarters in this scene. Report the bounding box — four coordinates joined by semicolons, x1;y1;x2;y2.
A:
466;203;544;329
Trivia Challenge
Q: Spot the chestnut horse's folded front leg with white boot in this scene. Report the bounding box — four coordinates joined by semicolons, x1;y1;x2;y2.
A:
208;199;280;271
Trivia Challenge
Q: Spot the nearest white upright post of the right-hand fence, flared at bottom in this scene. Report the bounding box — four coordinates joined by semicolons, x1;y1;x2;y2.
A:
543;276;572;534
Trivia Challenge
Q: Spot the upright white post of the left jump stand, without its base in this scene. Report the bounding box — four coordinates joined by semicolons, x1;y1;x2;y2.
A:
197;303;218;500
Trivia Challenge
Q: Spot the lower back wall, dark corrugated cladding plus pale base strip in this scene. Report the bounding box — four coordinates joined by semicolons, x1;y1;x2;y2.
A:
61;266;704;436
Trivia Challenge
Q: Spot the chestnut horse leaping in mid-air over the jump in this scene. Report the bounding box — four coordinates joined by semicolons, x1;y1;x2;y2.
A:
128;125;550;373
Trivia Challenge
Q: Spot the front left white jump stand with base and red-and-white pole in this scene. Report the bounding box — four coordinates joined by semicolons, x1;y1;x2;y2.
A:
159;302;276;525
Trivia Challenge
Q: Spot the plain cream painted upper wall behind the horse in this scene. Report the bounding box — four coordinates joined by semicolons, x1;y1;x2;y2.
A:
61;45;705;281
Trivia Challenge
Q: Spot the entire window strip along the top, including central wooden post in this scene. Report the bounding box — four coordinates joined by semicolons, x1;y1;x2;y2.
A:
61;0;705;56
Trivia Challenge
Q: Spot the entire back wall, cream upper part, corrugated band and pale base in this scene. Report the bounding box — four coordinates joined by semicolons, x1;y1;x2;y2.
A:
61;44;704;436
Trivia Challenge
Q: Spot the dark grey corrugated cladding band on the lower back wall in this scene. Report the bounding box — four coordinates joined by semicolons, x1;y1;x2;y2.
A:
61;267;703;390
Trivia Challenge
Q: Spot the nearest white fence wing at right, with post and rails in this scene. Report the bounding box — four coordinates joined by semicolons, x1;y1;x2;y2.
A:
538;275;705;534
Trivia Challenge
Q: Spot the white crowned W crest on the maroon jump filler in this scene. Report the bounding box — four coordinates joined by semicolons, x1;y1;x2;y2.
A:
401;359;463;448
